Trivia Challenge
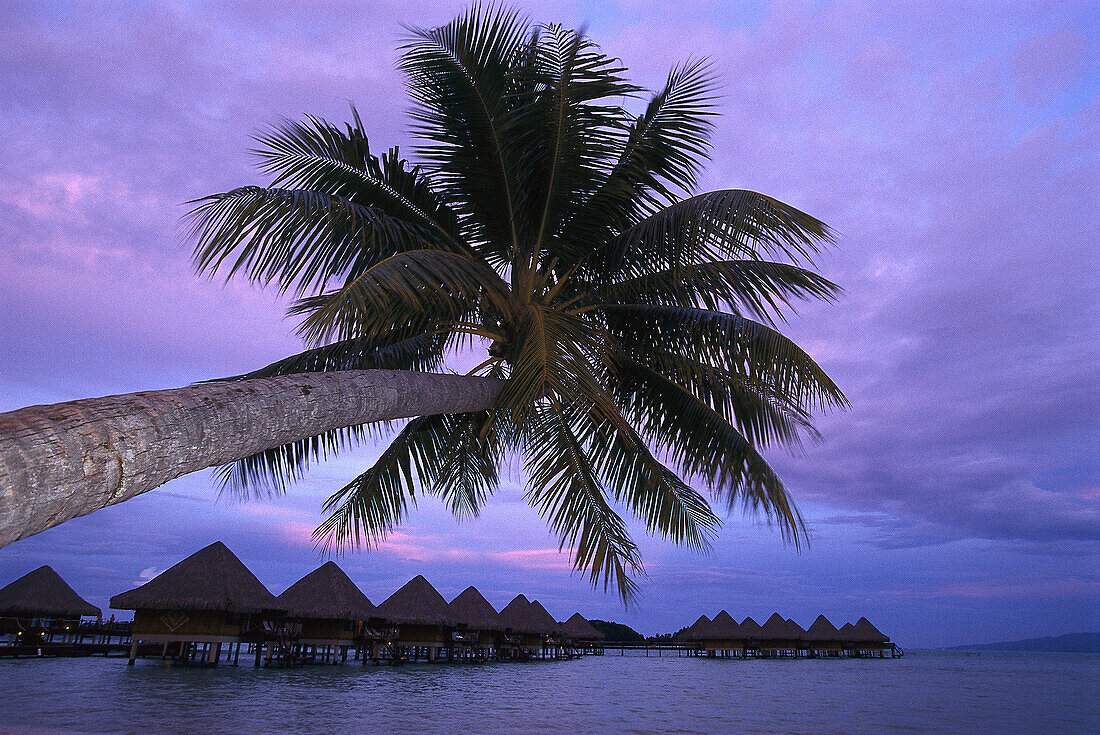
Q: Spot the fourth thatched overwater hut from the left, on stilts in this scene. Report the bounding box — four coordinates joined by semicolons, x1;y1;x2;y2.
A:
378;574;454;661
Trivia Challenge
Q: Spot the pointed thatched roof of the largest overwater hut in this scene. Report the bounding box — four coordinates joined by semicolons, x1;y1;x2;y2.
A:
111;541;283;613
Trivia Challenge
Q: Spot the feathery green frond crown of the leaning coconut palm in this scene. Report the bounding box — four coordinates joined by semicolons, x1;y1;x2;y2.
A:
191;7;846;601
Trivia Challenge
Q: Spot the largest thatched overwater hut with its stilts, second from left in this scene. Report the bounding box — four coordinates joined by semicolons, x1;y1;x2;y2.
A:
111;541;283;666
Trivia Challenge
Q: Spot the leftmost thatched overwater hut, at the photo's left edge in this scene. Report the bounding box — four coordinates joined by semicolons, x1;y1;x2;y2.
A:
0;566;100;645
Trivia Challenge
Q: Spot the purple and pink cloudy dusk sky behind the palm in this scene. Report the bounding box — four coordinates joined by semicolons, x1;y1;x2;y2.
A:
0;0;1100;647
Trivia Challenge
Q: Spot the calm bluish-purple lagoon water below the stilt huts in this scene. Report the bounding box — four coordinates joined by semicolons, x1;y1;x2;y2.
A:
0;651;1100;735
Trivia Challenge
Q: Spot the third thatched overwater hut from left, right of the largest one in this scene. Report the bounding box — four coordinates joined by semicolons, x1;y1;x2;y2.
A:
276;561;377;662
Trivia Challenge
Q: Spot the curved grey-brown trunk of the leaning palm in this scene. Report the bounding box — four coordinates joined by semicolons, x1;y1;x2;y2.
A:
0;370;501;547
